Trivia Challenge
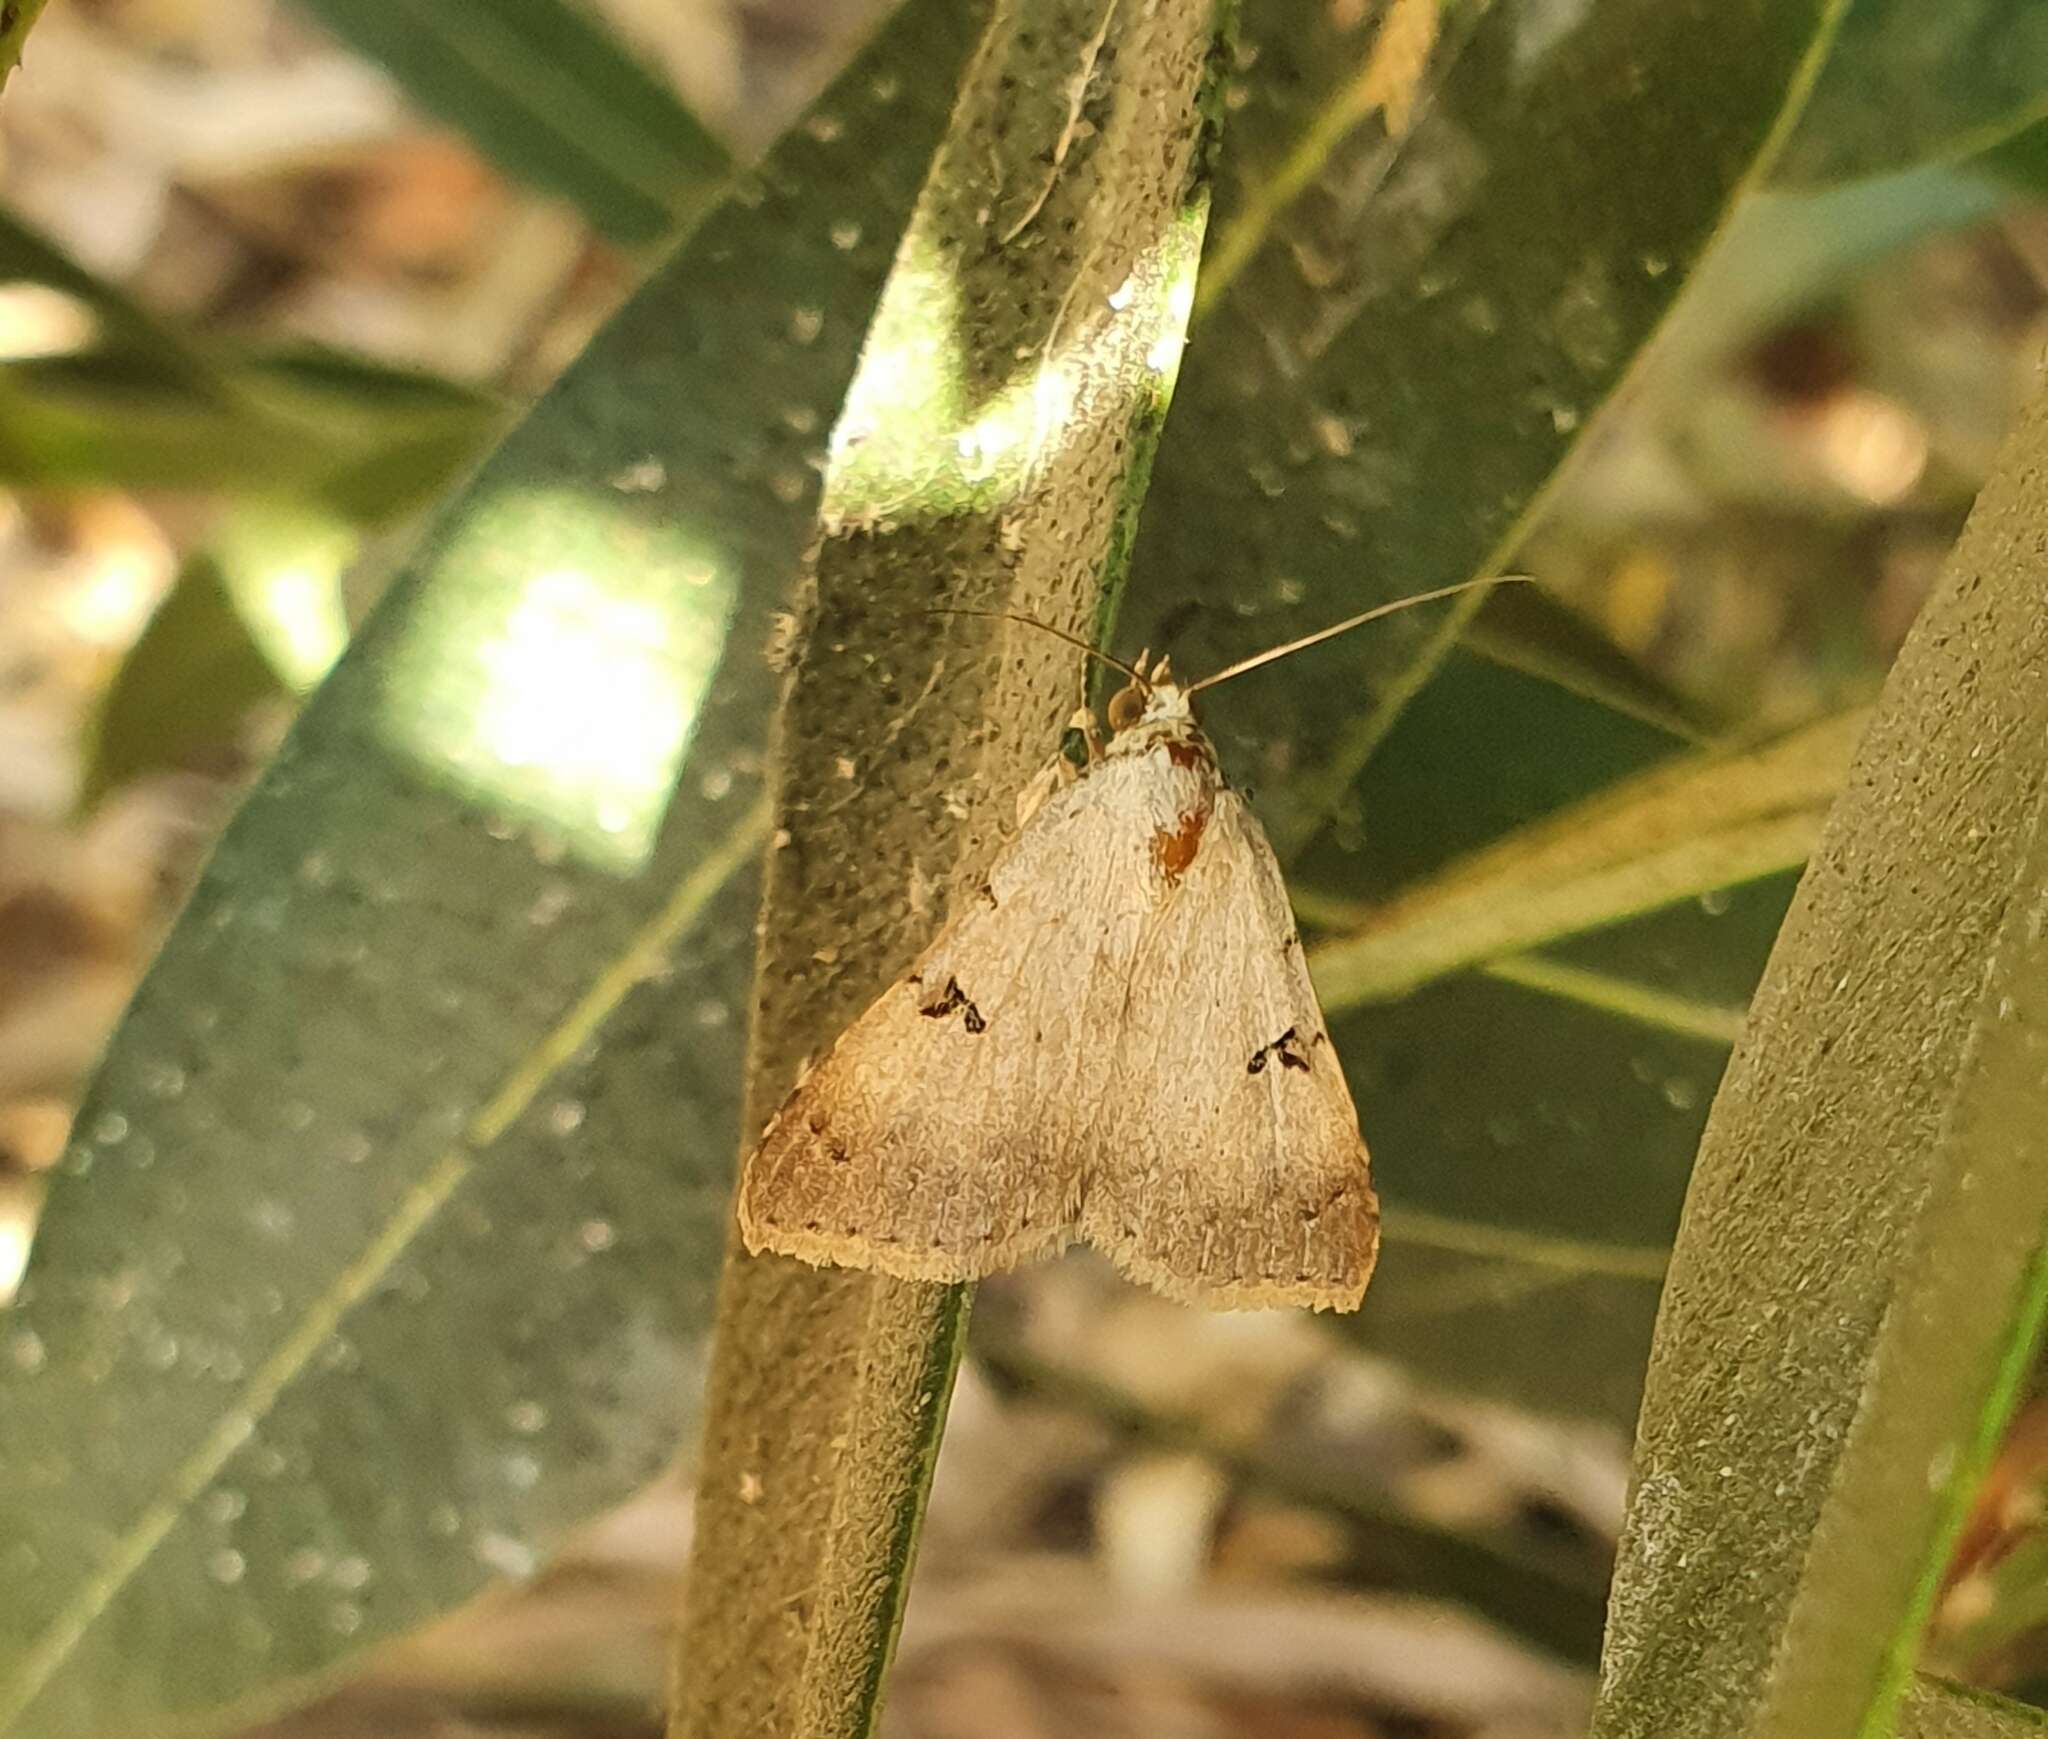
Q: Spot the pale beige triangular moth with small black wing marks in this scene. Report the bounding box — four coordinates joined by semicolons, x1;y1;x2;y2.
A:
739;582;1485;1311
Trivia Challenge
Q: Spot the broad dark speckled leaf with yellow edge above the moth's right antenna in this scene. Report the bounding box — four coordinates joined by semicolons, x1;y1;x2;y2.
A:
1126;0;1841;854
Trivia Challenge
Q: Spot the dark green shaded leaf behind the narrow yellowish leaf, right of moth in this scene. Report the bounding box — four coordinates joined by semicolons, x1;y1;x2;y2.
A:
1296;649;1792;1426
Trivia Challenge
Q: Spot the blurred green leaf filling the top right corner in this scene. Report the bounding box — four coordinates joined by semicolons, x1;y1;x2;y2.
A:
1778;0;2048;182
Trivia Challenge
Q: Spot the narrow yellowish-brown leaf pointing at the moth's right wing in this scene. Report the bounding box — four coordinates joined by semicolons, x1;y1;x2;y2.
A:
1309;709;1868;1012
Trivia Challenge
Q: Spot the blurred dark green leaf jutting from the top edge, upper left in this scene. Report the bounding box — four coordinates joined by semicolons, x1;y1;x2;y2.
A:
303;0;729;244
